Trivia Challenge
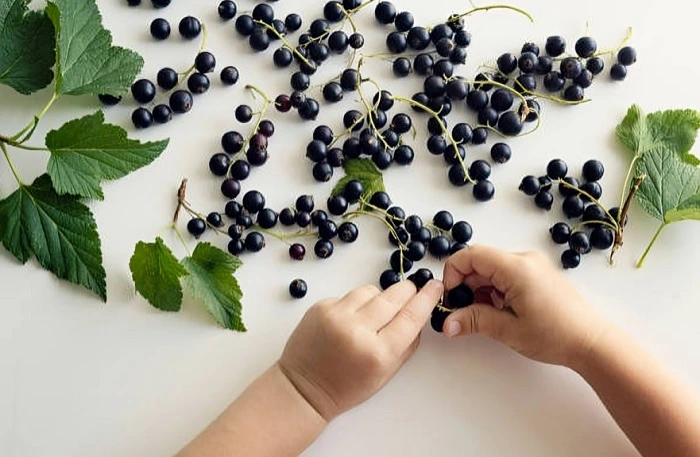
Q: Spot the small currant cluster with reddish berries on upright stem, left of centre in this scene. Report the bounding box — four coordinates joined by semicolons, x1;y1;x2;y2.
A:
209;100;275;199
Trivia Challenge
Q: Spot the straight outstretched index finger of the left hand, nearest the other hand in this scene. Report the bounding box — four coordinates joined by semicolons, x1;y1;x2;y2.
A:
379;280;444;354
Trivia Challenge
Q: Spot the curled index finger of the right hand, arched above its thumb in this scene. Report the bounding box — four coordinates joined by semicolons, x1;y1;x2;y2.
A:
442;245;519;294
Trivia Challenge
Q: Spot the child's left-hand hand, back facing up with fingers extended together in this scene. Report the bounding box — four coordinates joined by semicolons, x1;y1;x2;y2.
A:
279;281;443;421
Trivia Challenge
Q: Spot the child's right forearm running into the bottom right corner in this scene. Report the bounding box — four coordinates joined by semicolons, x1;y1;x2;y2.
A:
573;329;700;457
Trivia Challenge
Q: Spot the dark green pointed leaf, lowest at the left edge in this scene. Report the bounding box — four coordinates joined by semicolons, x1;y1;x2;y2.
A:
0;175;107;301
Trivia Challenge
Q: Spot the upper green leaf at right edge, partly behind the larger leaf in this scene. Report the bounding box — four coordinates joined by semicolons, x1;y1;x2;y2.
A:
616;105;700;165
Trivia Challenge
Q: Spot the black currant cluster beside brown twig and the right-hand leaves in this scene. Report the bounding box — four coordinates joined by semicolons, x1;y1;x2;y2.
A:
520;159;627;269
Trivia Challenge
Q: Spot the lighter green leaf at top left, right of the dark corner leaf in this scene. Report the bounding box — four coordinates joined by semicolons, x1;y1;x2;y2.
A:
46;0;143;95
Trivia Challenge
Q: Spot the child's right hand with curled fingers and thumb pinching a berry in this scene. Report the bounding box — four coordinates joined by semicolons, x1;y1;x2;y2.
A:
443;246;607;367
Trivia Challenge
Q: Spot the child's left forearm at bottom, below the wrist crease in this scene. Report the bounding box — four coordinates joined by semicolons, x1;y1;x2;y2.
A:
178;364;326;457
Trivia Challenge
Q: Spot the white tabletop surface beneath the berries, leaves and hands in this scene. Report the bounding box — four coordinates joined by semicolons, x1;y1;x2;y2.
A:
0;0;700;457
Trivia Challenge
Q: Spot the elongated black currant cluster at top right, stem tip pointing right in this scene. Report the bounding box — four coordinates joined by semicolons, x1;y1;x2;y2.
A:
489;36;637;103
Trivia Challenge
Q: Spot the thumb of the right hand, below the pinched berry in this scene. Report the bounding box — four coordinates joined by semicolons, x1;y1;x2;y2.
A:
443;305;516;339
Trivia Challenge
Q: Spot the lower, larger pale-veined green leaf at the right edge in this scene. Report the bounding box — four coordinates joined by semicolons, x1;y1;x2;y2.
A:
635;147;700;222
